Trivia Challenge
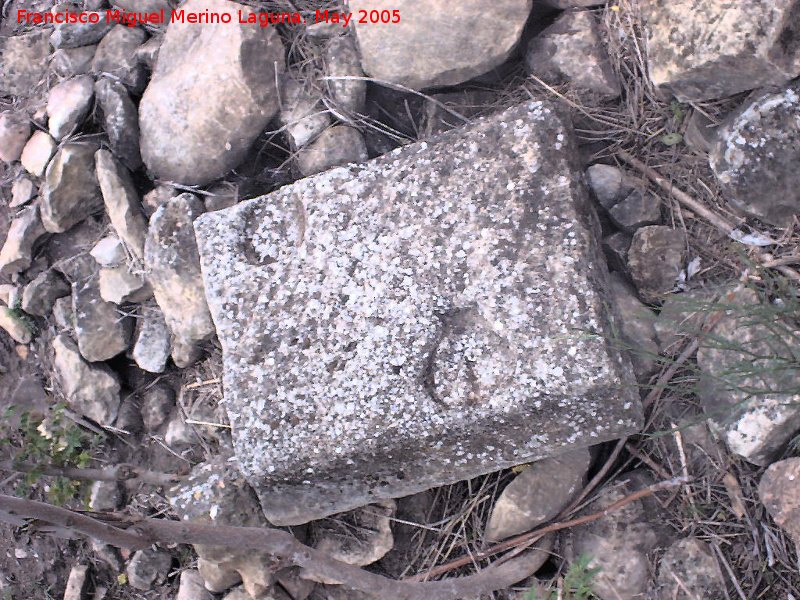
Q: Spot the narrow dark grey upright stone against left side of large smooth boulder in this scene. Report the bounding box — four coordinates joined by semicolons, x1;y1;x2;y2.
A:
94;77;142;171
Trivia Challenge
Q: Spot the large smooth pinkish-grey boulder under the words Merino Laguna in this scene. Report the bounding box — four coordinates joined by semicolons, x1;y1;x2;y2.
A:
139;0;284;184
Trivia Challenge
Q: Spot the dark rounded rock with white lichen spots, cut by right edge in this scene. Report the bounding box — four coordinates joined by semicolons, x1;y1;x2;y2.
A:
709;82;800;227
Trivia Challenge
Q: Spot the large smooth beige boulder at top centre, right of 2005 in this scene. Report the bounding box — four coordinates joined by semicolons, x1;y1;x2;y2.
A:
349;0;533;90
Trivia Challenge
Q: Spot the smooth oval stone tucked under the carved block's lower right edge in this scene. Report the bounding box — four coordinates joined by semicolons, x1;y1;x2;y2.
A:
484;448;592;541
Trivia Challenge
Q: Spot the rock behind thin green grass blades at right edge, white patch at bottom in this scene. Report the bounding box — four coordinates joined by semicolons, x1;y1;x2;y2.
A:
697;289;800;465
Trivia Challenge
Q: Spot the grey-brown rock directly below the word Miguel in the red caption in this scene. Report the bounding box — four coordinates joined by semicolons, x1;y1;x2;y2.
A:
92;25;147;94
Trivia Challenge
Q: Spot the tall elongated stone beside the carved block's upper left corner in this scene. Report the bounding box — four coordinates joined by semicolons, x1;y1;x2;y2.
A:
144;194;214;367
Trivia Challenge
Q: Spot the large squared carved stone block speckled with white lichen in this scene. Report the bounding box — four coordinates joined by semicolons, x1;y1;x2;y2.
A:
195;101;641;524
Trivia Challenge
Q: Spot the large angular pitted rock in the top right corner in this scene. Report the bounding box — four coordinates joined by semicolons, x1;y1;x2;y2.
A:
642;0;800;101
